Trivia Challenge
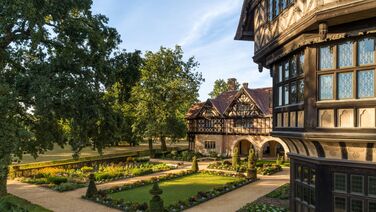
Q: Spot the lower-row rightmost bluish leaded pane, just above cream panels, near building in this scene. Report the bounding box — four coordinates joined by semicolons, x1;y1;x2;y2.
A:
358;70;375;98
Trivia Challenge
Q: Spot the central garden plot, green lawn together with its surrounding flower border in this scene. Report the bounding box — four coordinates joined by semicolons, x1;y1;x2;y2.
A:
85;171;254;211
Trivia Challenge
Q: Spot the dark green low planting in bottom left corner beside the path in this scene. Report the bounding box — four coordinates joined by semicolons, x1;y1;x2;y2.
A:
0;194;50;212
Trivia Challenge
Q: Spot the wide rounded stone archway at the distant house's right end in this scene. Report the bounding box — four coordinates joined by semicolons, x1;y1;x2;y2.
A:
260;139;290;159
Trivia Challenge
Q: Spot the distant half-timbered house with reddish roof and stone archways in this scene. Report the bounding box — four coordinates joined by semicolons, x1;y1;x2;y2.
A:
186;79;289;157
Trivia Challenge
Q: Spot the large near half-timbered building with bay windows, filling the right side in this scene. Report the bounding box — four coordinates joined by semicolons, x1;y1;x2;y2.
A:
235;0;376;212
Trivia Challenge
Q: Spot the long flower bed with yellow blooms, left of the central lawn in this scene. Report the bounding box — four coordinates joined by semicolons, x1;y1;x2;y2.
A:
20;161;172;192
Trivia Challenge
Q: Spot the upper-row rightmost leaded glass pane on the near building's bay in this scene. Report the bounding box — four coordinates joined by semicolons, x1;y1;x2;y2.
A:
358;38;375;65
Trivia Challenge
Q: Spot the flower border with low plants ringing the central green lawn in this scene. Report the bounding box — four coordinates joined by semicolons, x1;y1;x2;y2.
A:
85;171;253;211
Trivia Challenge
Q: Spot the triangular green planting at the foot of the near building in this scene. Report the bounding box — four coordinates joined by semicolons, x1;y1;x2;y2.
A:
238;183;290;212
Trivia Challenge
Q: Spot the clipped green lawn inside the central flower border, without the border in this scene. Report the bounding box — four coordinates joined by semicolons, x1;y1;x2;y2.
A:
109;173;238;206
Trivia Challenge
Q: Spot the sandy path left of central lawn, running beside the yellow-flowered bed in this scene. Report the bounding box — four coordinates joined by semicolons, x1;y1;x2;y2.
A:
8;161;212;212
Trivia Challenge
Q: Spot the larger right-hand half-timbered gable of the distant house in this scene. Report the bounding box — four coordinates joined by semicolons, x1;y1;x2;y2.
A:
225;92;263;117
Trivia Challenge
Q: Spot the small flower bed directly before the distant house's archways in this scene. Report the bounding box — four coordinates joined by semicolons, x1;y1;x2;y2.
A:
208;160;282;175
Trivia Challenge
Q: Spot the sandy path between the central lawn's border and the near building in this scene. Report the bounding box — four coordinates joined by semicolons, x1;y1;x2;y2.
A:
186;168;290;212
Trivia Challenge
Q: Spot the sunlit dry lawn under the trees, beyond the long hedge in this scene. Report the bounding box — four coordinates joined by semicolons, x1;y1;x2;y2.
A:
21;142;188;164
